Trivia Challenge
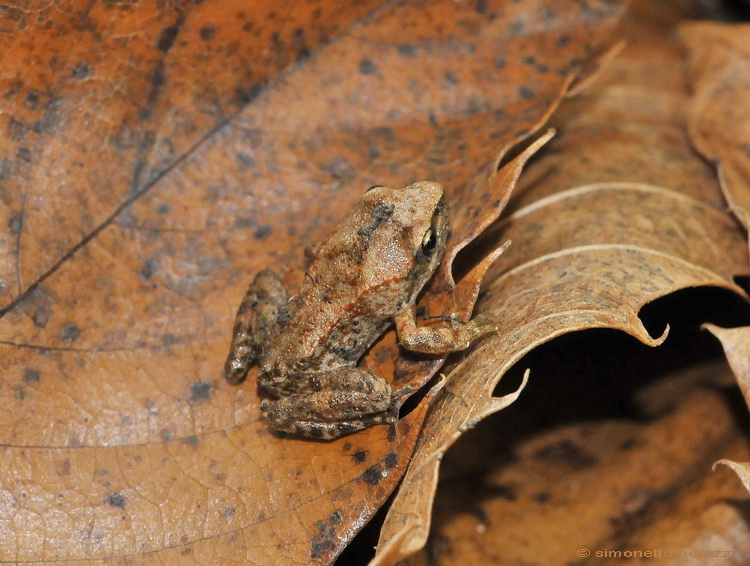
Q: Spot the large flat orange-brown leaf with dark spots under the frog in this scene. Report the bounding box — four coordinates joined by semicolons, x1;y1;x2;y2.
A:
0;0;622;564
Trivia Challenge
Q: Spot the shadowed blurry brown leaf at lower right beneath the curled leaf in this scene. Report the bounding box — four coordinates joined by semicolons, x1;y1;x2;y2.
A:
426;362;750;566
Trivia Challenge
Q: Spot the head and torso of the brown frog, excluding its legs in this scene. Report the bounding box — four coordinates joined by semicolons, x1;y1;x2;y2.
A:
263;182;447;372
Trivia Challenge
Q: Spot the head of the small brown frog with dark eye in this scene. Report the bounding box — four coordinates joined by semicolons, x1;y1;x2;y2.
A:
358;181;450;304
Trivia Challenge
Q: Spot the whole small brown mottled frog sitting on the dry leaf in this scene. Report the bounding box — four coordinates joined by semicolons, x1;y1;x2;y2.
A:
224;181;497;440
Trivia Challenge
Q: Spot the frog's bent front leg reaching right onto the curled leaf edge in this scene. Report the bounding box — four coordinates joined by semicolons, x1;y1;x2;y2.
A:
393;308;497;354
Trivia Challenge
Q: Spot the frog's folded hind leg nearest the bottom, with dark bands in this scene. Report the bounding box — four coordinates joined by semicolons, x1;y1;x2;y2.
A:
260;367;397;439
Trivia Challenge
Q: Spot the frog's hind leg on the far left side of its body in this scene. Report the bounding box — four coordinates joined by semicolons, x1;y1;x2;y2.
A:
224;269;288;384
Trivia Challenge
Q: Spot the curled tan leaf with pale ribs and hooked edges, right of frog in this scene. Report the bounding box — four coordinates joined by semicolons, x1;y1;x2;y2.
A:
376;3;748;564
